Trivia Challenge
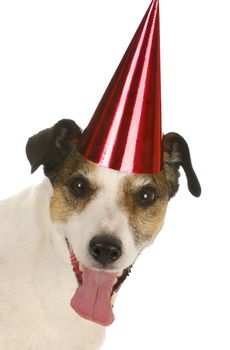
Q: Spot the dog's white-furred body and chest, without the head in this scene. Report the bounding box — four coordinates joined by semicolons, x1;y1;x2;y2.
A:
0;179;104;350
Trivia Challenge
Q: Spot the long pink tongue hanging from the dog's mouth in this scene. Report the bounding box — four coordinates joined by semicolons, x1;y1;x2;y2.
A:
71;268;116;326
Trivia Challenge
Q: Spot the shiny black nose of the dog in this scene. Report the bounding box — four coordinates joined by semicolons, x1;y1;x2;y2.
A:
89;236;122;266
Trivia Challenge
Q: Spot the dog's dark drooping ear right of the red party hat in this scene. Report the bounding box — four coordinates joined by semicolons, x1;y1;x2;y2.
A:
163;132;201;197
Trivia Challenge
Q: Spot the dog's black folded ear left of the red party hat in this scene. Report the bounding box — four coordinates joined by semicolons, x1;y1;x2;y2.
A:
26;119;82;176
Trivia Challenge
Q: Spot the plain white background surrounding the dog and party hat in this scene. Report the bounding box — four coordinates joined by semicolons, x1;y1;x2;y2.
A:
0;0;230;350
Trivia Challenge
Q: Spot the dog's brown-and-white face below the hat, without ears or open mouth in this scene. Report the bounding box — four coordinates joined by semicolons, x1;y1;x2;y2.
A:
50;152;169;271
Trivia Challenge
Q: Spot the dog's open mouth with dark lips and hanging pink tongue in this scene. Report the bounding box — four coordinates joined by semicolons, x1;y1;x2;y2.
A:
66;239;132;326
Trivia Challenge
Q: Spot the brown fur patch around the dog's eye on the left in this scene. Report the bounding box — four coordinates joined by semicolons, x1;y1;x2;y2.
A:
50;152;98;222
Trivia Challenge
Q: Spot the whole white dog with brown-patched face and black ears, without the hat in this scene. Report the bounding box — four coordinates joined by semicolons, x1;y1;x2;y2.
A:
0;119;201;350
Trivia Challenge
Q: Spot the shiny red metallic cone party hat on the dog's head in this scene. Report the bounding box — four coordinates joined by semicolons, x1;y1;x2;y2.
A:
79;0;162;174
